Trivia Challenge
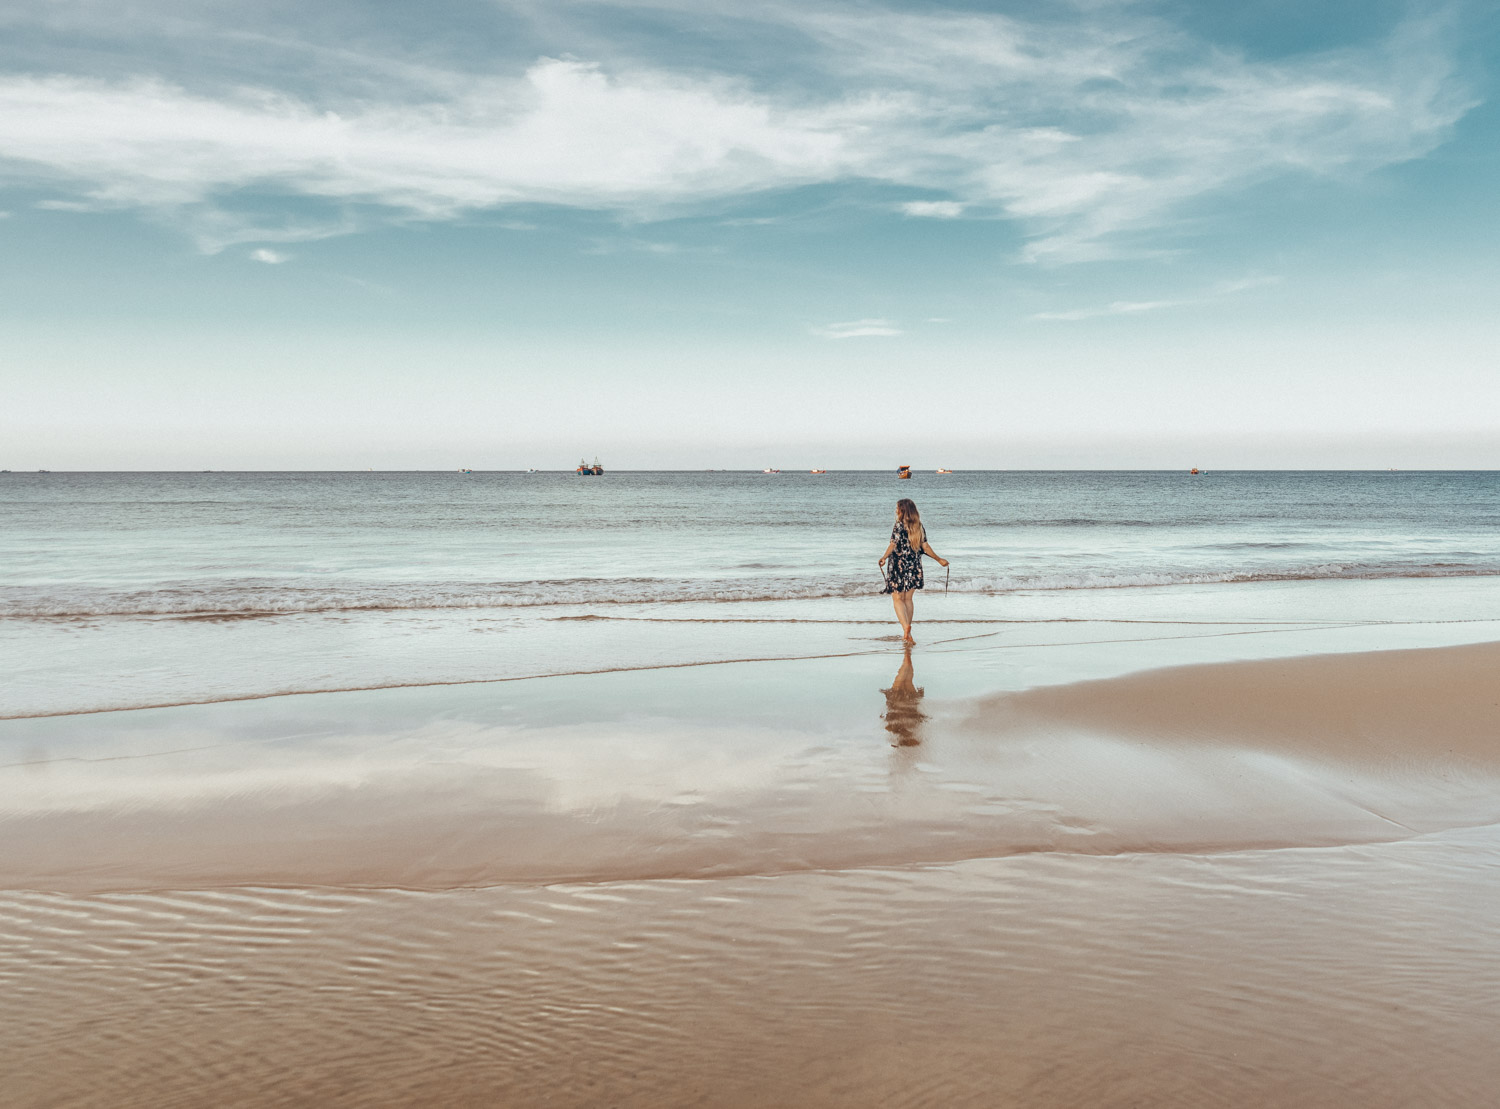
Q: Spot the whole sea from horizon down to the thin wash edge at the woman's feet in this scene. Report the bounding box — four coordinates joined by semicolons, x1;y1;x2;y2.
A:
0;471;1500;716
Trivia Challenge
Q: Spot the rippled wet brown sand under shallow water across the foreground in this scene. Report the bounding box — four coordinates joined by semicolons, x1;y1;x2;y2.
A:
0;833;1500;1109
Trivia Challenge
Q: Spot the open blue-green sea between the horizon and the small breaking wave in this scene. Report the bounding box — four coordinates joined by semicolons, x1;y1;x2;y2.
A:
0;473;1500;617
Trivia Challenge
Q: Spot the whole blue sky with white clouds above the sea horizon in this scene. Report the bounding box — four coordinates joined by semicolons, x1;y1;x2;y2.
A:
0;0;1500;470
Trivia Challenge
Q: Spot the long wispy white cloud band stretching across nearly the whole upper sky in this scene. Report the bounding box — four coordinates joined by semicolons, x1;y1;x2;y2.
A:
0;3;1475;260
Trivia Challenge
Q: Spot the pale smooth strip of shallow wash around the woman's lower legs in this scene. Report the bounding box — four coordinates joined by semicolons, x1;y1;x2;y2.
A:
14;578;1500;722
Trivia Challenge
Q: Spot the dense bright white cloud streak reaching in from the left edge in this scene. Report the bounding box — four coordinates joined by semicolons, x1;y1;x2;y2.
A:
0;59;846;240
